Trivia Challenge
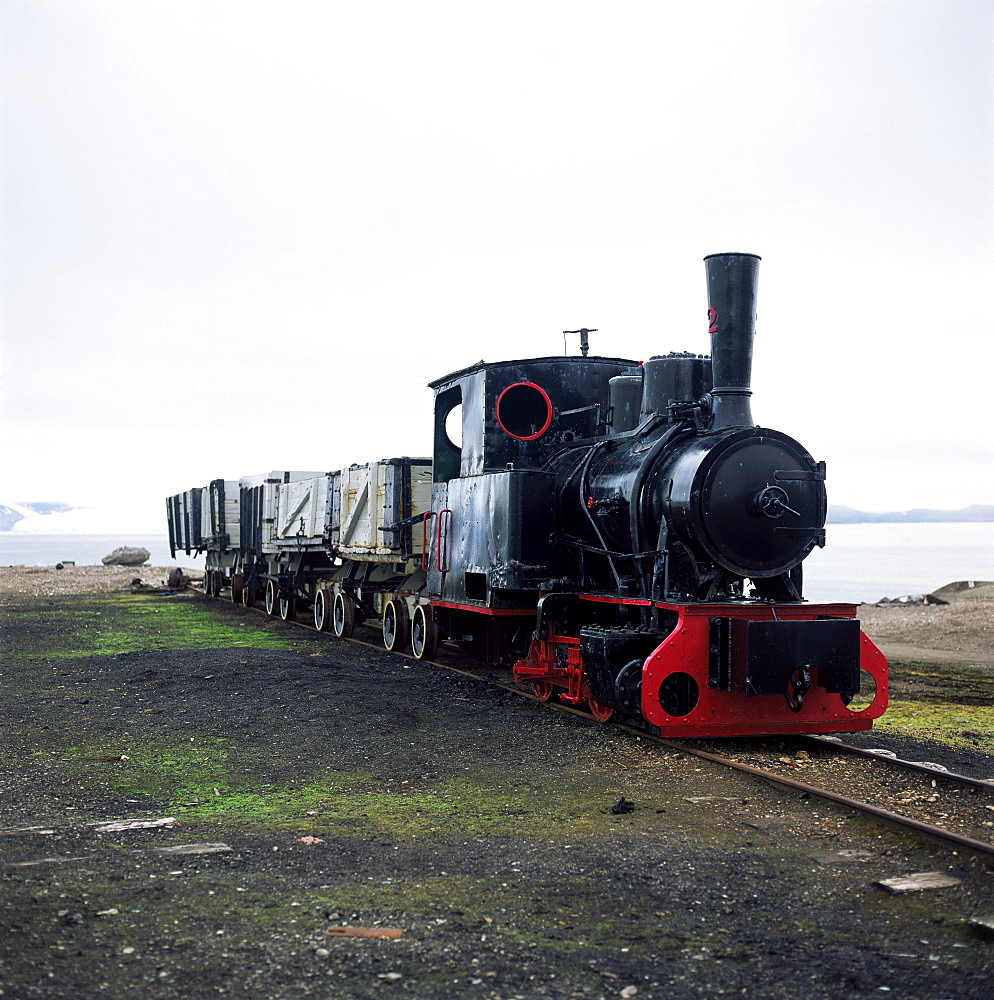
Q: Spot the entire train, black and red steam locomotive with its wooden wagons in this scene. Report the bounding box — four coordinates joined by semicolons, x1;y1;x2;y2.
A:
167;254;887;736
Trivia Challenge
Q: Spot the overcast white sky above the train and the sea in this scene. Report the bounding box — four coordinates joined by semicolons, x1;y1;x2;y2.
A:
0;0;994;528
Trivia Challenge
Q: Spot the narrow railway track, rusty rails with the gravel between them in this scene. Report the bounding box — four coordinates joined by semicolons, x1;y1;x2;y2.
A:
190;587;994;865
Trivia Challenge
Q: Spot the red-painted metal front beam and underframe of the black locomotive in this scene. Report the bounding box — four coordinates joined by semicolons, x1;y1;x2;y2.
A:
514;594;887;736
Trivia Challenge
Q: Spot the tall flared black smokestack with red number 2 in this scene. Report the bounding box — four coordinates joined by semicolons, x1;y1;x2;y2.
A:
704;253;760;430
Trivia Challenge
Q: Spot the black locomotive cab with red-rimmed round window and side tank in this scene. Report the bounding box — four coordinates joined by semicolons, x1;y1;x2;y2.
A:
427;357;634;652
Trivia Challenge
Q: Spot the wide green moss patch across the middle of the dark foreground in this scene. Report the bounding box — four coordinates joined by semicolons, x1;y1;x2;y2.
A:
44;737;628;843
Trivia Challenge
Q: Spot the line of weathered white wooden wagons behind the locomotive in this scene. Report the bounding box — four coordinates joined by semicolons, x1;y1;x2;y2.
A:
166;457;440;659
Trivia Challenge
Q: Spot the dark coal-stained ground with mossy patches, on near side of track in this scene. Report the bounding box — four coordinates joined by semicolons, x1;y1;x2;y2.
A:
0;596;994;1000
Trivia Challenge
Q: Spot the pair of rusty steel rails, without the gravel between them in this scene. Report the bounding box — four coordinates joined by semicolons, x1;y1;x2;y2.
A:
189;587;994;865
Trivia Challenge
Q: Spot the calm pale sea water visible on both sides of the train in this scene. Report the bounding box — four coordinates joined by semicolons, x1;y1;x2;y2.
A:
0;522;994;604
